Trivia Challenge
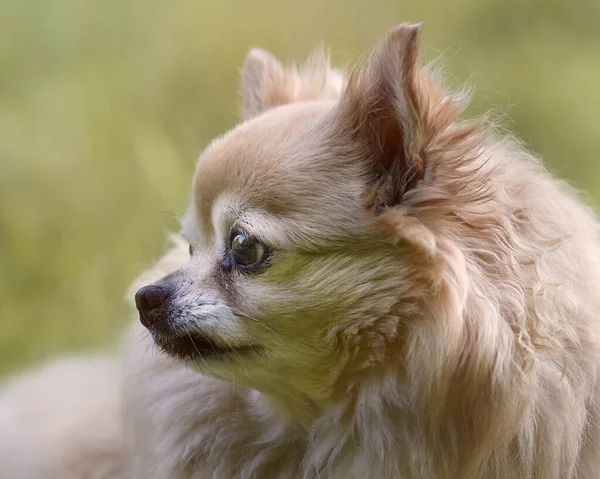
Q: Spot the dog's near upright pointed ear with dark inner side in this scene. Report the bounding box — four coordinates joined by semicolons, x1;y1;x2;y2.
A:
339;23;461;209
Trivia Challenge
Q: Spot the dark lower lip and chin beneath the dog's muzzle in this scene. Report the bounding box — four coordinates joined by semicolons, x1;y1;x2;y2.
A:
152;333;263;361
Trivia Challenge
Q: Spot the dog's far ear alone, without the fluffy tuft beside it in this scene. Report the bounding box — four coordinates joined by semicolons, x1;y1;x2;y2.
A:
242;48;297;120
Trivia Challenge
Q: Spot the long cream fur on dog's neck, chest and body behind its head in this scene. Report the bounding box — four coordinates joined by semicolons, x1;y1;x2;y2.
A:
126;136;600;479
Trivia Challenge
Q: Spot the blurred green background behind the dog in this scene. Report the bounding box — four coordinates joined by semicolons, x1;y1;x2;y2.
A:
0;0;600;374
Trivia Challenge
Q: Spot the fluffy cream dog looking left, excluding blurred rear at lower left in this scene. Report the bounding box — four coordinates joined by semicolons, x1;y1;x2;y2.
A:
1;24;600;479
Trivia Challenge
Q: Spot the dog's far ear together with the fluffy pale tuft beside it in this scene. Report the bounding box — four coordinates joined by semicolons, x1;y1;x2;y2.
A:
242;48;344;120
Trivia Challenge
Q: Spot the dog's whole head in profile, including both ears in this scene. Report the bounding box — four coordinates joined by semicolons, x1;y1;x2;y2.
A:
136;25;478;402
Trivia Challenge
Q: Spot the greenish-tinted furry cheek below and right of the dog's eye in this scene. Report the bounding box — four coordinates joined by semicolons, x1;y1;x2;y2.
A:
225;250;412;360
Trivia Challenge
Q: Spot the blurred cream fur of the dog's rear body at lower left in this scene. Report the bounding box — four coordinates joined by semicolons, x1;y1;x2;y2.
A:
0;357;129;479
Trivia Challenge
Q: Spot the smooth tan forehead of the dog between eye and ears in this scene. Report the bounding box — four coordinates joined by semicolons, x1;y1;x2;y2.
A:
194;102;358;231
